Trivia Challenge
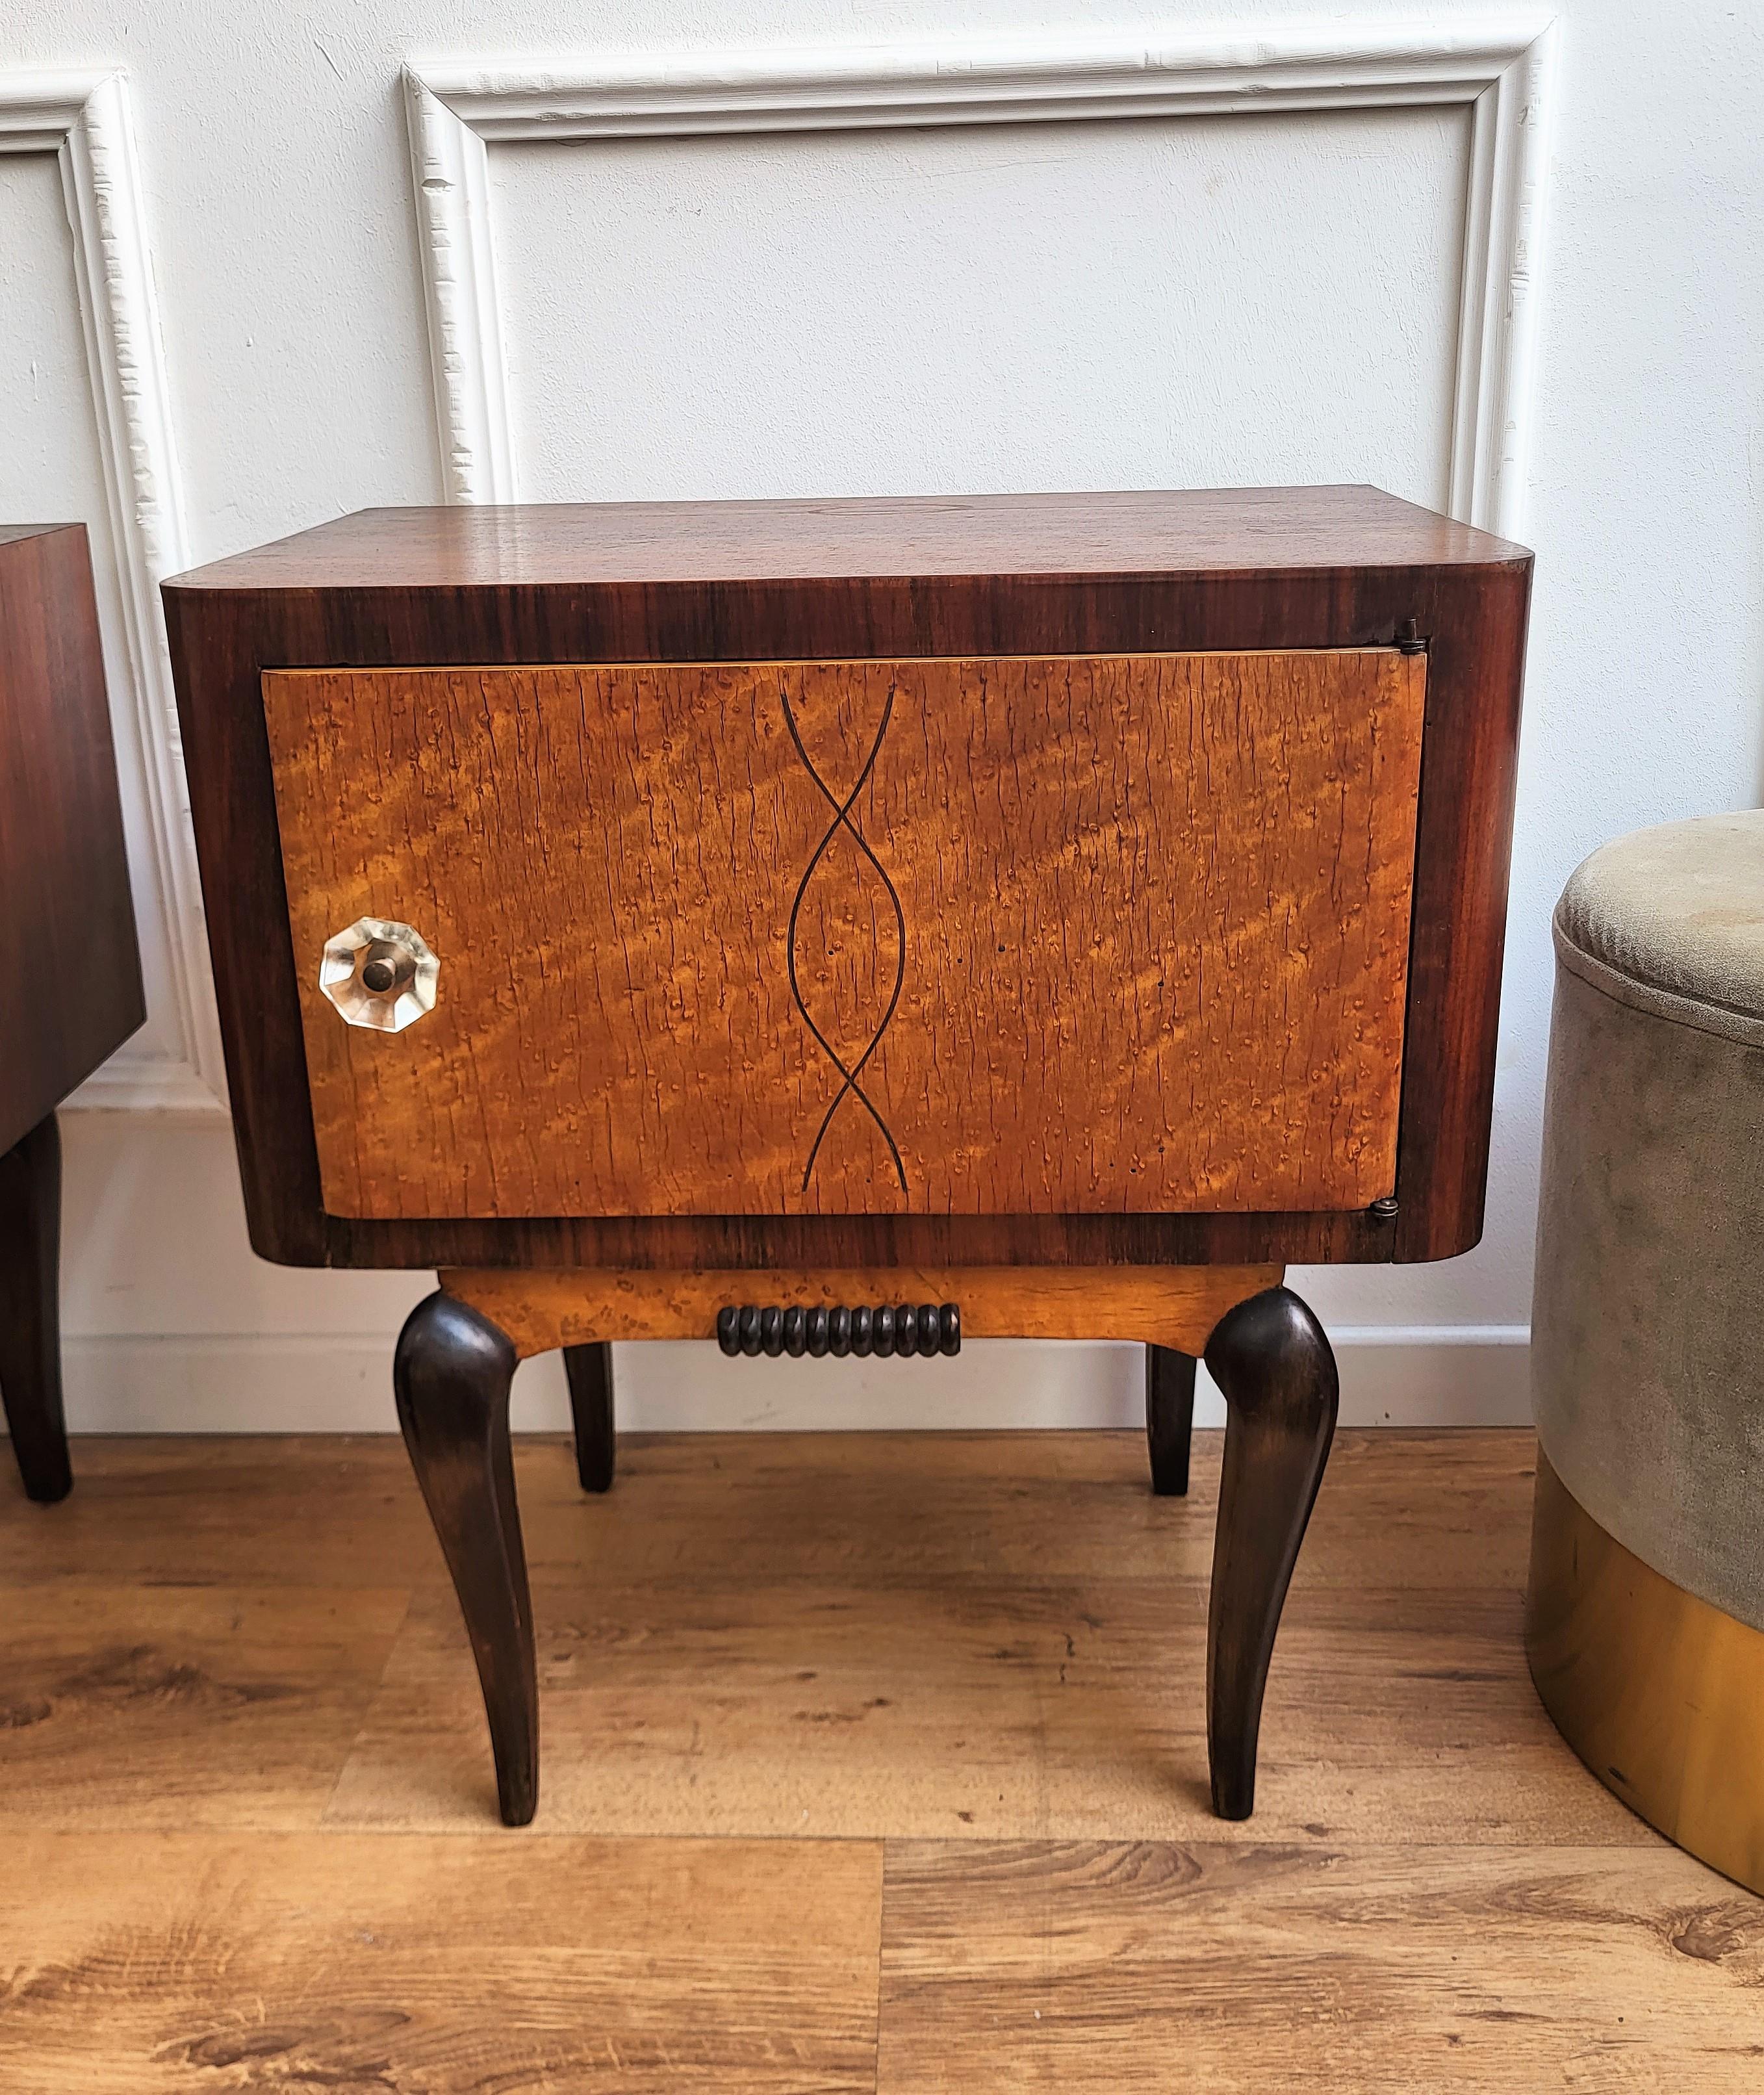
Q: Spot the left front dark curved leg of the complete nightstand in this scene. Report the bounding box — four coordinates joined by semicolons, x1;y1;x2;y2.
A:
392;1292;539;1827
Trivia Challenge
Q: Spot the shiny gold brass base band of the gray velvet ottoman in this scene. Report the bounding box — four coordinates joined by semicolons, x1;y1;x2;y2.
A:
1525;1448;1764;1892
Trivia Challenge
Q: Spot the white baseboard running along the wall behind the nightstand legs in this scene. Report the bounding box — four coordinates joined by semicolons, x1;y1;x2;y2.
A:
38;1324;1531;1433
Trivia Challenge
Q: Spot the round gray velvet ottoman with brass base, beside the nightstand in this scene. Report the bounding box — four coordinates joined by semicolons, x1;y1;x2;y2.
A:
1525;813;1764;1892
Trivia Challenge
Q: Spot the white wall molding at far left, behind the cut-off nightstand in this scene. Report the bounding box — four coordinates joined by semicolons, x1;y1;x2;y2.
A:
0;71;224;1114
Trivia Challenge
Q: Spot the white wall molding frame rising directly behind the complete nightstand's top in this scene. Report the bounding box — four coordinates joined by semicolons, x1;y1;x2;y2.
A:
404;15;1555;536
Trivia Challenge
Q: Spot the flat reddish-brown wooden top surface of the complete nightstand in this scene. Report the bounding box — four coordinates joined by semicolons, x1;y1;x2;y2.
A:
168;486;1529;591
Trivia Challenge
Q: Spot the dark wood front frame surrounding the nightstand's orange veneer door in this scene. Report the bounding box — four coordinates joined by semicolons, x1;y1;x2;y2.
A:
166;563;1525;1268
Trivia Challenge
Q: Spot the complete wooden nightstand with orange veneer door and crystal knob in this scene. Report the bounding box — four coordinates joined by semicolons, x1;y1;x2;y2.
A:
166;488;1529;1823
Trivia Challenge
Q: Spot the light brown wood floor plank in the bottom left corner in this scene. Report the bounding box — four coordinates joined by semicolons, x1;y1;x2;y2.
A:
0;1835;882;2095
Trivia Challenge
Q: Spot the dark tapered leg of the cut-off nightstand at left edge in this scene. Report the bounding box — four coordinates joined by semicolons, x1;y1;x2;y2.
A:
0;1112;73;1506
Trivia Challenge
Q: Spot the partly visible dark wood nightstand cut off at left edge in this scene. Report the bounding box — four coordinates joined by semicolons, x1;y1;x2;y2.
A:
0;524;147;1500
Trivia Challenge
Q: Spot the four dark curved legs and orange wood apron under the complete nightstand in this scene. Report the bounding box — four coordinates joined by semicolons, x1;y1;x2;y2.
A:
427;1265;1307;1825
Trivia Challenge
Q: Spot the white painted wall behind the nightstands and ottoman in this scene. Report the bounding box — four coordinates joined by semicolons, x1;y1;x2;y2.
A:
0;0;1764;1427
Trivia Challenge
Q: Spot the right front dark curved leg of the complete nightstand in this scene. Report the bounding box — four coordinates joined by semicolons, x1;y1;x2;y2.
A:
1205;1289;1341;1818
